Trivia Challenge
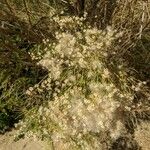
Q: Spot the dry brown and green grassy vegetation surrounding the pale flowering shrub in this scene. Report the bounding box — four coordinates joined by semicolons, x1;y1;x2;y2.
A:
0;0;150;150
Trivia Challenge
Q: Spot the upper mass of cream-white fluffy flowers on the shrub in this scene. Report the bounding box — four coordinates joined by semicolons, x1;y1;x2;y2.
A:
38;26;117;75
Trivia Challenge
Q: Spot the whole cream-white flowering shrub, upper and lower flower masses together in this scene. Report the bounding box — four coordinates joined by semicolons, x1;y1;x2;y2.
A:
20;15;127;150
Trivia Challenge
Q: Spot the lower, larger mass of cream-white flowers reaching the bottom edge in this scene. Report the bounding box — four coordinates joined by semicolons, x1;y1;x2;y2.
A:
20;82;127;150
